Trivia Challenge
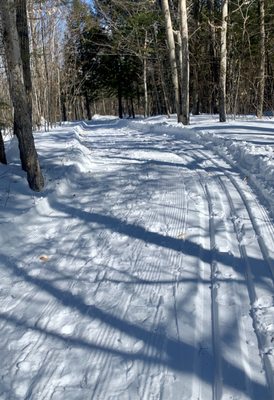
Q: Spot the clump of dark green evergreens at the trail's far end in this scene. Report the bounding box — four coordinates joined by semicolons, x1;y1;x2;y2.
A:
64;0;143;119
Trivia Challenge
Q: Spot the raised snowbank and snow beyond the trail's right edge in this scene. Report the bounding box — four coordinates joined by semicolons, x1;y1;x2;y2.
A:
128;115;274;217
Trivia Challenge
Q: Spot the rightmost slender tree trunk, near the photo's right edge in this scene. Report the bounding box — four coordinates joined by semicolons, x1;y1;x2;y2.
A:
257;0;266;118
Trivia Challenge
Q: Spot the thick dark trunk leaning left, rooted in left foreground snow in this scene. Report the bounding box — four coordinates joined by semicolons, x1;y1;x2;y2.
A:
0;0;44;191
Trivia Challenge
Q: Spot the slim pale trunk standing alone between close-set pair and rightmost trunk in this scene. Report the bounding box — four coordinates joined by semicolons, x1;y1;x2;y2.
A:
219;0;228;122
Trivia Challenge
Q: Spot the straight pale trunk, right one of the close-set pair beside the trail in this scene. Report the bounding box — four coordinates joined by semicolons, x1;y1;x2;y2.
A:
179;0;189;125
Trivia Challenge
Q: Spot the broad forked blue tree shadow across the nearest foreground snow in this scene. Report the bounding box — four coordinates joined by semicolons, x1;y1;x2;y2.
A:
0;256;267;400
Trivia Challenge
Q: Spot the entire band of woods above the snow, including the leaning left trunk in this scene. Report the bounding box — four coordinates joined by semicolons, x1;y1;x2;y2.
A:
0;0;274;190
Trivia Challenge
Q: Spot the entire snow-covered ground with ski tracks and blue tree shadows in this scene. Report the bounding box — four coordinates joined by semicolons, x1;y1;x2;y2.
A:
0;116;274;400
